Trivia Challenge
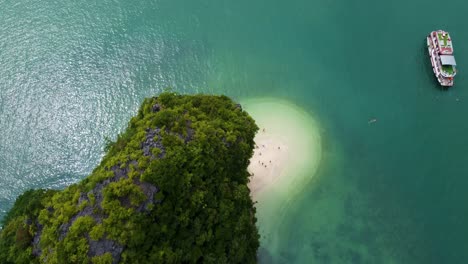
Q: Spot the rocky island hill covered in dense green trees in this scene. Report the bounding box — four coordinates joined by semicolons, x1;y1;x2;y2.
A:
0;93;259;263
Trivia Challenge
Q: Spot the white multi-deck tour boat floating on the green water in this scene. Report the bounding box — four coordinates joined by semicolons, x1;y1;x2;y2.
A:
427;30;457;87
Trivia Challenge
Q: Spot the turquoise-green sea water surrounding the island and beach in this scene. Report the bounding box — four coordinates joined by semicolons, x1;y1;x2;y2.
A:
0;0;468;263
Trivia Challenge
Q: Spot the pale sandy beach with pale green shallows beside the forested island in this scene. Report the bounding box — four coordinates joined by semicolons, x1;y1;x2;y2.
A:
242;98;321;200
